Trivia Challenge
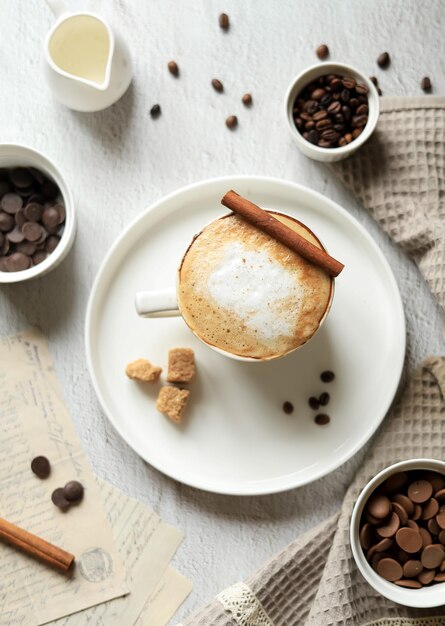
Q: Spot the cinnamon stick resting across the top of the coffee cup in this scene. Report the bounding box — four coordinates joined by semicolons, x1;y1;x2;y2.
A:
221;190;344;277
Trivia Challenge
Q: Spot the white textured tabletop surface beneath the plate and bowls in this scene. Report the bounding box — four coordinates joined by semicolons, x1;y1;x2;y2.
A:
0;0;445;617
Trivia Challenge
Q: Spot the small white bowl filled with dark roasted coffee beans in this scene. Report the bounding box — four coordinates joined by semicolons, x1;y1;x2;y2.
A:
284;63;379;163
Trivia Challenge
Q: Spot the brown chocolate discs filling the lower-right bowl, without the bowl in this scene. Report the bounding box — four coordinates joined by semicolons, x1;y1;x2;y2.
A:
359;470;445;589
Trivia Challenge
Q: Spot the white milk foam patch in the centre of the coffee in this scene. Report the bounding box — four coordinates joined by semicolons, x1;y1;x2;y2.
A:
207;242;304;340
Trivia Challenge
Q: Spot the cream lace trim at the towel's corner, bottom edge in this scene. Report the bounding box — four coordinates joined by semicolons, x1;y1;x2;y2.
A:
217;583;274;626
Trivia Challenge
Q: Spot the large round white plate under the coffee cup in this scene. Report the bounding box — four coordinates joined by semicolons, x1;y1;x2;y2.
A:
86;176;405;495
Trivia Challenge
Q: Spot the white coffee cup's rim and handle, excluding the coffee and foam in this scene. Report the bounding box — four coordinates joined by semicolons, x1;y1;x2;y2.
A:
135;211;335;363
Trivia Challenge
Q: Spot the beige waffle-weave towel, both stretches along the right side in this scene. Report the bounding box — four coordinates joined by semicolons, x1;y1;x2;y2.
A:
182;97;445;626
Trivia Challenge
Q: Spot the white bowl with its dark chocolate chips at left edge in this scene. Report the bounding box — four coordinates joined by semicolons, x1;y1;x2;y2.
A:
0;144;76;283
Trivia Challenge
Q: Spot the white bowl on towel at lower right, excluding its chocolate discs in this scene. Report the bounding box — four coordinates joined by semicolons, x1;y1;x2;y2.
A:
350;459;445;609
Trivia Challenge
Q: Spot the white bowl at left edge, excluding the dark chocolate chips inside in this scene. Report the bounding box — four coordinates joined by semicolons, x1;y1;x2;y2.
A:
0;143;76;283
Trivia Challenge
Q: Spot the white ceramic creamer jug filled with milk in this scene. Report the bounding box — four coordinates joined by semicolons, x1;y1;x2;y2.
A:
45;0;132;111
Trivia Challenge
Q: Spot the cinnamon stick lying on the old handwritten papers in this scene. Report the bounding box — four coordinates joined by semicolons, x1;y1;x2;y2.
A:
0;518;75;572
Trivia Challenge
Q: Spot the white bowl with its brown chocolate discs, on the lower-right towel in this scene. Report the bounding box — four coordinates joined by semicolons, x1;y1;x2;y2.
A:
350;459;445;608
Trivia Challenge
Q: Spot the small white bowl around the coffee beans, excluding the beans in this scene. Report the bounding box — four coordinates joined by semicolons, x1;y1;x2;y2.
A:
284;63;380;163
